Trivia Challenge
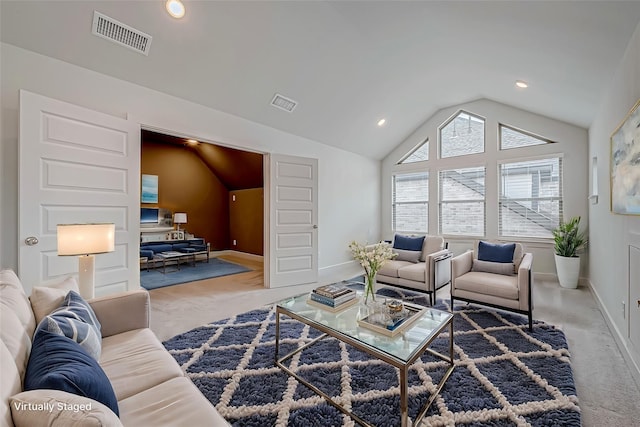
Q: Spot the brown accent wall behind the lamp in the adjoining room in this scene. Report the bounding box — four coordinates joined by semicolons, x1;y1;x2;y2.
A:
141;141;229;250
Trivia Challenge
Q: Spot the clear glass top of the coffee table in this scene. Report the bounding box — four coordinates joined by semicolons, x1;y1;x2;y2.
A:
277;292;453;362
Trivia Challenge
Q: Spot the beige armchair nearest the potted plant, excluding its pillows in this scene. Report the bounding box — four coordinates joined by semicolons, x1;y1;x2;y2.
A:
451;243;533;331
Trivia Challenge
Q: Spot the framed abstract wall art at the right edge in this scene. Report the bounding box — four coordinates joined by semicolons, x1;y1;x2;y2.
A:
611;101;640;215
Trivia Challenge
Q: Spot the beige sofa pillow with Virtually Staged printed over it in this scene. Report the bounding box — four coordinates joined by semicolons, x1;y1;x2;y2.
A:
11;390;122;427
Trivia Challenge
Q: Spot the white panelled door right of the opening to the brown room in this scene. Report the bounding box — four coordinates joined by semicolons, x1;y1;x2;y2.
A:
269;154;318;288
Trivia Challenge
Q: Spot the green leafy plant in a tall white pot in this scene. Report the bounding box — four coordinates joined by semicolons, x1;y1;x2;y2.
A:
552;216;587;289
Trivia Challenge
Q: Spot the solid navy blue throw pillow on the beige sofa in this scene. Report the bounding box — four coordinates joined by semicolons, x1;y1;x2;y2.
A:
24;329;120;416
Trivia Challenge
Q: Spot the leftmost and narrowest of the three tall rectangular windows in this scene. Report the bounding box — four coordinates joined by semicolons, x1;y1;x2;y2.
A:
391;172;429;233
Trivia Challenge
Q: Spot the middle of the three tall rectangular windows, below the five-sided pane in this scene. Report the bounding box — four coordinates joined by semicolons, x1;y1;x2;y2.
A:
438;167;485;236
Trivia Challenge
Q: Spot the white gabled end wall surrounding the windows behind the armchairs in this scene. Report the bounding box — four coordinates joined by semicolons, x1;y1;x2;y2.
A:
381;99;588;276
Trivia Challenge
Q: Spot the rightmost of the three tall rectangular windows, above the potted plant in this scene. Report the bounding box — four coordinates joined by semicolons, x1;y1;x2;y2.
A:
499;157;562;238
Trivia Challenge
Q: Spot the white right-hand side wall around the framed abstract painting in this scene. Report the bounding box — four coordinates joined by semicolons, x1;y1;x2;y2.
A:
589;20;640;382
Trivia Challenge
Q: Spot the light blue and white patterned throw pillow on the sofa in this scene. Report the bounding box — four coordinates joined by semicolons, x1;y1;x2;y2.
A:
38;291;102;360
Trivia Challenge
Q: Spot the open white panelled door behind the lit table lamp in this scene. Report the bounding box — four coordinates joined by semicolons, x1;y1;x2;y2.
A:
18;91;140;295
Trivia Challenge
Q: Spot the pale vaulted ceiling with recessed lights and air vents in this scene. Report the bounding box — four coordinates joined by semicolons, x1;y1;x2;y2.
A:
0;0;640;159
